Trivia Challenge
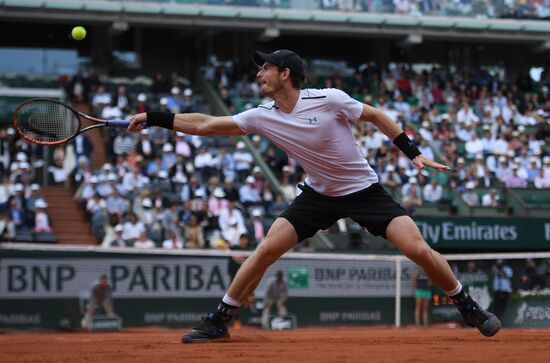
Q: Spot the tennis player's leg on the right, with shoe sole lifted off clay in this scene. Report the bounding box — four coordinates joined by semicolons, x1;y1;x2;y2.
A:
386;216;502;336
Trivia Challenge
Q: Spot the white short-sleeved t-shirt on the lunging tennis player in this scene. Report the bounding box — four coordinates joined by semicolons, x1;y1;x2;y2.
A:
233;88;378;196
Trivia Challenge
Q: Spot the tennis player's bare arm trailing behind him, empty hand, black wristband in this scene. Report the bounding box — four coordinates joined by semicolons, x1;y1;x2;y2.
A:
361;105;449;170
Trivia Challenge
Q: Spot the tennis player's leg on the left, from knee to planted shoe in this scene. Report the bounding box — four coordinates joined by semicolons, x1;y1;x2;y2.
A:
182;218;298;343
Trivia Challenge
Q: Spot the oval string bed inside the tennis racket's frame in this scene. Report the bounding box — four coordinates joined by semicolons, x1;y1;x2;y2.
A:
15;100;80;142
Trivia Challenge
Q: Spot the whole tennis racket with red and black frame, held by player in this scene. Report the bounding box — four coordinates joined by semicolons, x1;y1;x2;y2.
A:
13;98;135;145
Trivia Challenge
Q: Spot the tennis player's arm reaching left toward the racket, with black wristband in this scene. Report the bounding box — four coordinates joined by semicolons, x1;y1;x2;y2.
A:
128;112;244;136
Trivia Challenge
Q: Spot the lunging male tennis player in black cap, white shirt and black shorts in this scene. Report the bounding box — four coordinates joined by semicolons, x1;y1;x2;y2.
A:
129;49;502;343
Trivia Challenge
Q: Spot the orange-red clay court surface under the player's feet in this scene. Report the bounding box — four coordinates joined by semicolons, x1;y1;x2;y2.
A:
0;327;550;363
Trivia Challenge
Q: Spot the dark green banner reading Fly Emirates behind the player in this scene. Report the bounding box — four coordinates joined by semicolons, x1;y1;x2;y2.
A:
415;217;550;251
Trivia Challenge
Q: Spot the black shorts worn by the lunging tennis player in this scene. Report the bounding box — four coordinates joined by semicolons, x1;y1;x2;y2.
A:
280;183;408;241
